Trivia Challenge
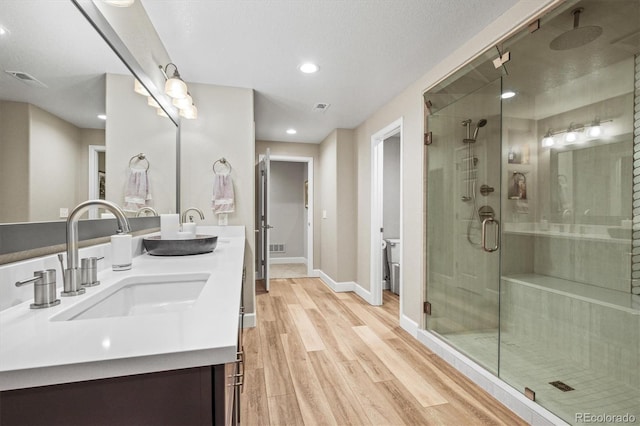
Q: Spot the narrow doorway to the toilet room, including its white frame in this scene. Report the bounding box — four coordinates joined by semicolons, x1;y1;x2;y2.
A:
370;118;402;314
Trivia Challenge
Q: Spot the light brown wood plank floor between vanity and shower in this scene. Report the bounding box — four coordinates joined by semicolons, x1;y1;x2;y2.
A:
241;278;526;426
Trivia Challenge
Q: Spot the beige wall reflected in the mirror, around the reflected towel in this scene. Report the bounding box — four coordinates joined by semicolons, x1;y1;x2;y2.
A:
105;74;176;213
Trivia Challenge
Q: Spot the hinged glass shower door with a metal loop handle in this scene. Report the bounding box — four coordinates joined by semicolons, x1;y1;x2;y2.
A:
427;76;501;374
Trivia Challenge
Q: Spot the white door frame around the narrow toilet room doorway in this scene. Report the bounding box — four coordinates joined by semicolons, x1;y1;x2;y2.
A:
369;117;404;306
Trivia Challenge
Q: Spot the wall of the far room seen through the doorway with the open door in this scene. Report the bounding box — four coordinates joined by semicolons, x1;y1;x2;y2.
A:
269;161;307;258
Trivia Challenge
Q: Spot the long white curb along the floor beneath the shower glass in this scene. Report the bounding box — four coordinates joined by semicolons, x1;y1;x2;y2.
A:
416;330;567;426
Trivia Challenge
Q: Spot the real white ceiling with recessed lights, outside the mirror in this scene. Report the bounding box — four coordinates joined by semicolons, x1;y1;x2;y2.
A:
141;0;517;143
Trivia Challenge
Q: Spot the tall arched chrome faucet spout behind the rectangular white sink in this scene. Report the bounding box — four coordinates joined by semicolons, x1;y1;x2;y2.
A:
58;200;131;296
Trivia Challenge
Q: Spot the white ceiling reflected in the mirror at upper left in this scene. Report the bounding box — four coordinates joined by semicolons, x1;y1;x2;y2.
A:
0;0;129;128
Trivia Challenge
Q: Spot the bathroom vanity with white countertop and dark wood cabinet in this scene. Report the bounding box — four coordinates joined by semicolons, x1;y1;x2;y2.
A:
0;226;245;425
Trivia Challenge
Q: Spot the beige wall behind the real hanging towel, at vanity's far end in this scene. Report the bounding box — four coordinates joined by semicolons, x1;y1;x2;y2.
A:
180;83;255;313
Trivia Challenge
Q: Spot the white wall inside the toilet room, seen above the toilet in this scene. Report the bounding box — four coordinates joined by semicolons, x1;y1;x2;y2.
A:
382;136;400;238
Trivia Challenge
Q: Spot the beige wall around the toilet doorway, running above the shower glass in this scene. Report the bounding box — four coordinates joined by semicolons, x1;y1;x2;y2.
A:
355;0;559;324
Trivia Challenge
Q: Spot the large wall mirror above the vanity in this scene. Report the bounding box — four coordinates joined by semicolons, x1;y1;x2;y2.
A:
0;1;179;255
